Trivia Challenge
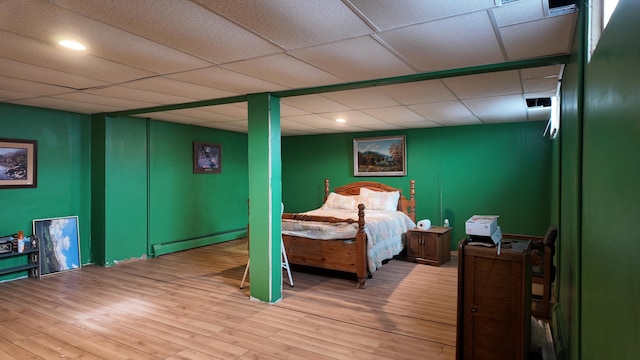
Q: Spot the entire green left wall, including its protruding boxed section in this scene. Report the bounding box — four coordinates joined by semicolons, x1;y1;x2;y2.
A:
0;104;248;280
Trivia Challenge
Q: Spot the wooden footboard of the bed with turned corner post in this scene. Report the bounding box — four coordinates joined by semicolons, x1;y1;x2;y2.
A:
282;204;368;288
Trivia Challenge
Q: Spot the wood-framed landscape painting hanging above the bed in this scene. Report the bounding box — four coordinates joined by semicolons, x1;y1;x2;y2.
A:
353;135;407;176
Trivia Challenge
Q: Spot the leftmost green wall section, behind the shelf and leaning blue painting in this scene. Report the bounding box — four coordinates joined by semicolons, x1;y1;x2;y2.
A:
0;104;92;279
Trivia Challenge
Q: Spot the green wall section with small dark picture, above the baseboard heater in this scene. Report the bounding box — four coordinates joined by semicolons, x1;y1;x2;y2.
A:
149;121;249;249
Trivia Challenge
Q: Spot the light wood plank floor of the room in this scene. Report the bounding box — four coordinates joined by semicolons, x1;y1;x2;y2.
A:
0;239;457;360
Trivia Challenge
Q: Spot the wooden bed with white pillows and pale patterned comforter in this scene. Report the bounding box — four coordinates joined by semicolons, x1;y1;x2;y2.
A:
282;179;416;288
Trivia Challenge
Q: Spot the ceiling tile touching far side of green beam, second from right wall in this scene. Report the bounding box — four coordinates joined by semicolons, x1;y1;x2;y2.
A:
442;70;522;99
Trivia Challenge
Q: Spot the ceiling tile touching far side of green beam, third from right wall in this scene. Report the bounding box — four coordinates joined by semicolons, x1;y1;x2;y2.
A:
376;80;456;105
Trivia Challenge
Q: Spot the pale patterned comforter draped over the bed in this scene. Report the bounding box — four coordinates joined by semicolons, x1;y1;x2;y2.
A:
282;209;416;273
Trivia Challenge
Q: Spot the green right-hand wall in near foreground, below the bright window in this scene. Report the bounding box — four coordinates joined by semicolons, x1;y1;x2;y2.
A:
581;0;640;359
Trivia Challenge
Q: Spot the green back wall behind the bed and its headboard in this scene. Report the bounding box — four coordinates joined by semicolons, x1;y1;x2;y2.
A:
282;122;552;249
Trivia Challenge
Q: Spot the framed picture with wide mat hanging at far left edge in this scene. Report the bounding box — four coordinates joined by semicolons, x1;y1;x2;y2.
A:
0;138;38;189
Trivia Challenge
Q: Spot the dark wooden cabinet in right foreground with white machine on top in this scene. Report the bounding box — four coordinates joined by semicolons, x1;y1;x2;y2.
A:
456;239;531;360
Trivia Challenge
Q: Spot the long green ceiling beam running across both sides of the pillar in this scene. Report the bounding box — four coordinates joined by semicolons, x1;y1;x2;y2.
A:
106;55;569;117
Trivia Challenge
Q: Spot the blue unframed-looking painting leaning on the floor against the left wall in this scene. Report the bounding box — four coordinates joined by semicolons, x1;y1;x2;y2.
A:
33;216;81;275
